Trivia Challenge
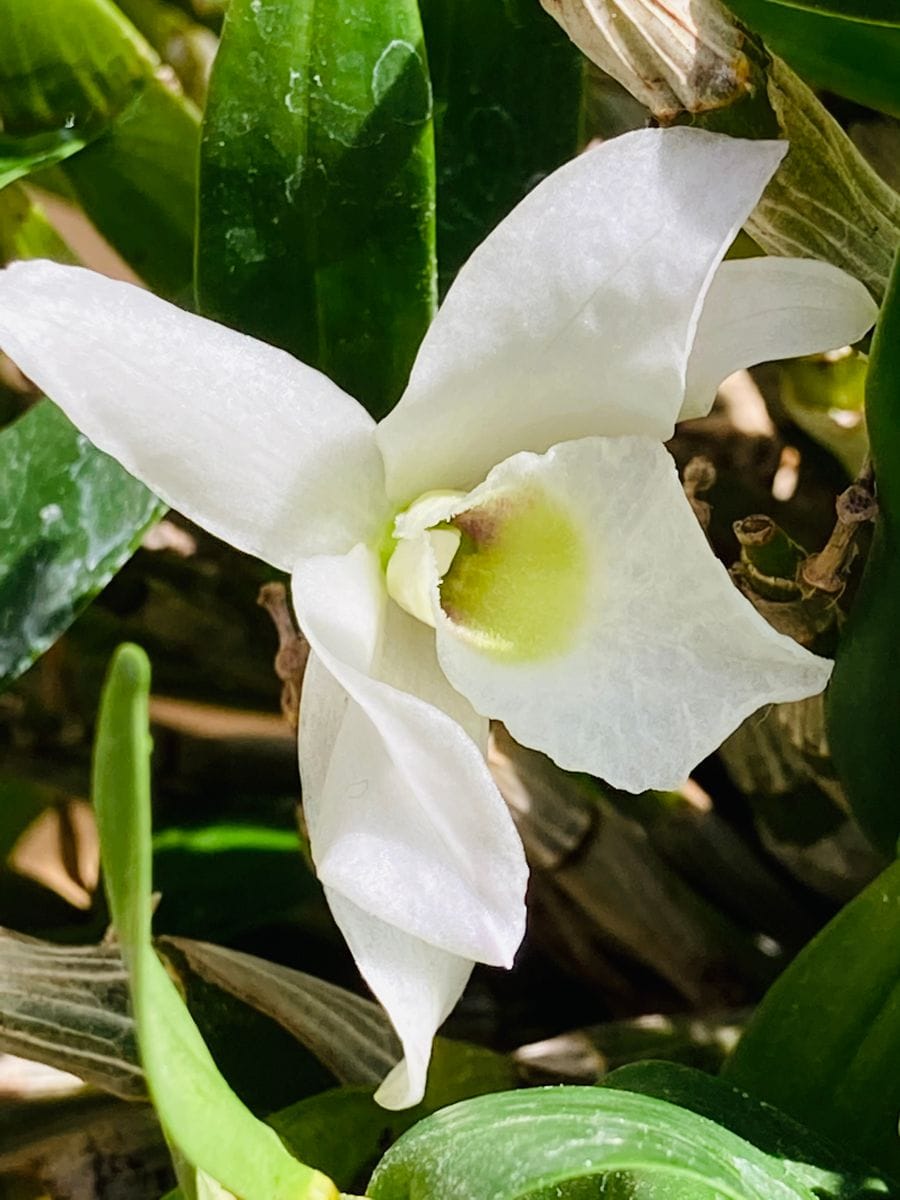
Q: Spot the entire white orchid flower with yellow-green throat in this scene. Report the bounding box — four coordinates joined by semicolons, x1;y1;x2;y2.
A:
0;128;875;1108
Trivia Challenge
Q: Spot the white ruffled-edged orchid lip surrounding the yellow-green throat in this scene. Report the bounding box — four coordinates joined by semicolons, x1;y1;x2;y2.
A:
434;438;832;792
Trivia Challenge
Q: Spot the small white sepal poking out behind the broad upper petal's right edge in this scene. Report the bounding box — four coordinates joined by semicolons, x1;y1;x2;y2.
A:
678;258;878;420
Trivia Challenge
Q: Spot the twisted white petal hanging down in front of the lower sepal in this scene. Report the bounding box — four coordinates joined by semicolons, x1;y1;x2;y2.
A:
293;546;527;966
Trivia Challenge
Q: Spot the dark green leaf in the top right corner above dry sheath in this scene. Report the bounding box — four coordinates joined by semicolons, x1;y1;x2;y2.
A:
727;0;900;116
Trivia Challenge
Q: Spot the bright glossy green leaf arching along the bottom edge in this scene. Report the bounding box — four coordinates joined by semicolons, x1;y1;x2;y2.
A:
367;1087;814;1200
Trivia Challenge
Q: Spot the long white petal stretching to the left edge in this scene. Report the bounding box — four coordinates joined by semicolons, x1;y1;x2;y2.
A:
0;262;385;569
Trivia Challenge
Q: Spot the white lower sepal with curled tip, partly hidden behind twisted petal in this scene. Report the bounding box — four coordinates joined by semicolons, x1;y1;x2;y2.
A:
300;652;475;1109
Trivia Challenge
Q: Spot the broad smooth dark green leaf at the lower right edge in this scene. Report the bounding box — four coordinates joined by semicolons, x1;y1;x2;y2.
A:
725;863;900;1178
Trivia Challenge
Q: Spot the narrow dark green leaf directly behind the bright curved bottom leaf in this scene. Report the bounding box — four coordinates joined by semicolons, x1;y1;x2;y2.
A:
602;1062;893;1200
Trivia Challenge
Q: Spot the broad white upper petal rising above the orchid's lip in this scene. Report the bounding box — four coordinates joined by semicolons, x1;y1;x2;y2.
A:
378;128;786;502
